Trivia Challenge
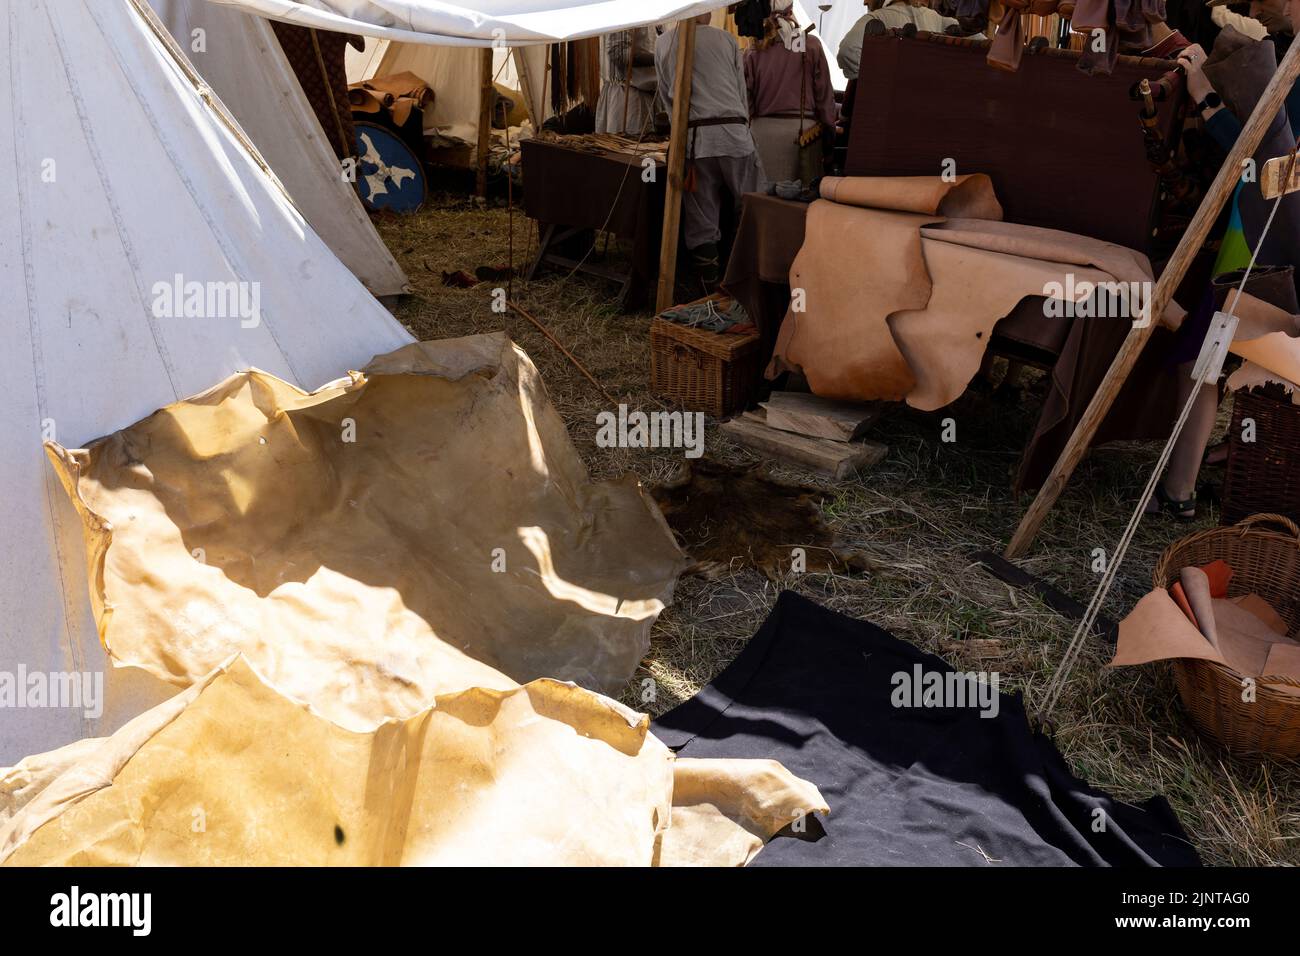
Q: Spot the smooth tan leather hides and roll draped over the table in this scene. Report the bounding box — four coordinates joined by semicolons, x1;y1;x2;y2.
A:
768;177;1183;411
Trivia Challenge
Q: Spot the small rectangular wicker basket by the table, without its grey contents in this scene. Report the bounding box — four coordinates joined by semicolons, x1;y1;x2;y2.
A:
650;304;759;418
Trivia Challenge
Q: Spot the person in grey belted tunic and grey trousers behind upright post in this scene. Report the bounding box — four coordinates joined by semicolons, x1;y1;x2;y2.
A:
654;13;763;293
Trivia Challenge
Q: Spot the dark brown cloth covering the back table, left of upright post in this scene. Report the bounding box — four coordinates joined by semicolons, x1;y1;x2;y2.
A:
520;139;668;303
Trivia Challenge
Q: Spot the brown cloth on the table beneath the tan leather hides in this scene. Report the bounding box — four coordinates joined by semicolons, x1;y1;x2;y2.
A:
723;194;1175;490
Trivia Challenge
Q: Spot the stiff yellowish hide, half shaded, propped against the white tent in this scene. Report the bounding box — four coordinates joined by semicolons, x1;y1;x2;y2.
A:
47;333;685;730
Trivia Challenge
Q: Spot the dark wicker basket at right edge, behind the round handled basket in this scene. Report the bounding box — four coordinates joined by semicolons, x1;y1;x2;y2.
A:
1219;389;1300;524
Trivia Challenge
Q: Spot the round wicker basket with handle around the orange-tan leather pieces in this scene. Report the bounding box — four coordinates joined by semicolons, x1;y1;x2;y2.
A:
1152;515;1300;757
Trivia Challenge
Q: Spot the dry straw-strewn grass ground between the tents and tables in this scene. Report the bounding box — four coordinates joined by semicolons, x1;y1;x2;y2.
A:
377;196;1300;865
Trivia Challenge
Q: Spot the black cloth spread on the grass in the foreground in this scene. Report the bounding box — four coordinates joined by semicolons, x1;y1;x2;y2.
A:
651;592;1197;866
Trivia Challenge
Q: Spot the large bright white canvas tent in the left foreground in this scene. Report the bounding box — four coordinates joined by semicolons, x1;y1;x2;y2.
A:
0;0;411;766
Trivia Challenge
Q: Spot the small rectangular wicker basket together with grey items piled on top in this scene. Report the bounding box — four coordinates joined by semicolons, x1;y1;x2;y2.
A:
650;294;759;418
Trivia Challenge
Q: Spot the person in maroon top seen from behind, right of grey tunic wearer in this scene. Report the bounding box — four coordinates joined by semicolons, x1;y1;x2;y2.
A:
745;0;837;185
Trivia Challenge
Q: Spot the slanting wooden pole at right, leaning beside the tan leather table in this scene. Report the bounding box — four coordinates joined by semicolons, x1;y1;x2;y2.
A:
1005;44;1300;558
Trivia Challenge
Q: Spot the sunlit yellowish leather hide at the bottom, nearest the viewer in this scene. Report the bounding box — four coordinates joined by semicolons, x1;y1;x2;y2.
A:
0;656;826;866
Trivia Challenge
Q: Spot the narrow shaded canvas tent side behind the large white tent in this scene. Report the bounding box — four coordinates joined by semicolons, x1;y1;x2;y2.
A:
151;0;408;295
